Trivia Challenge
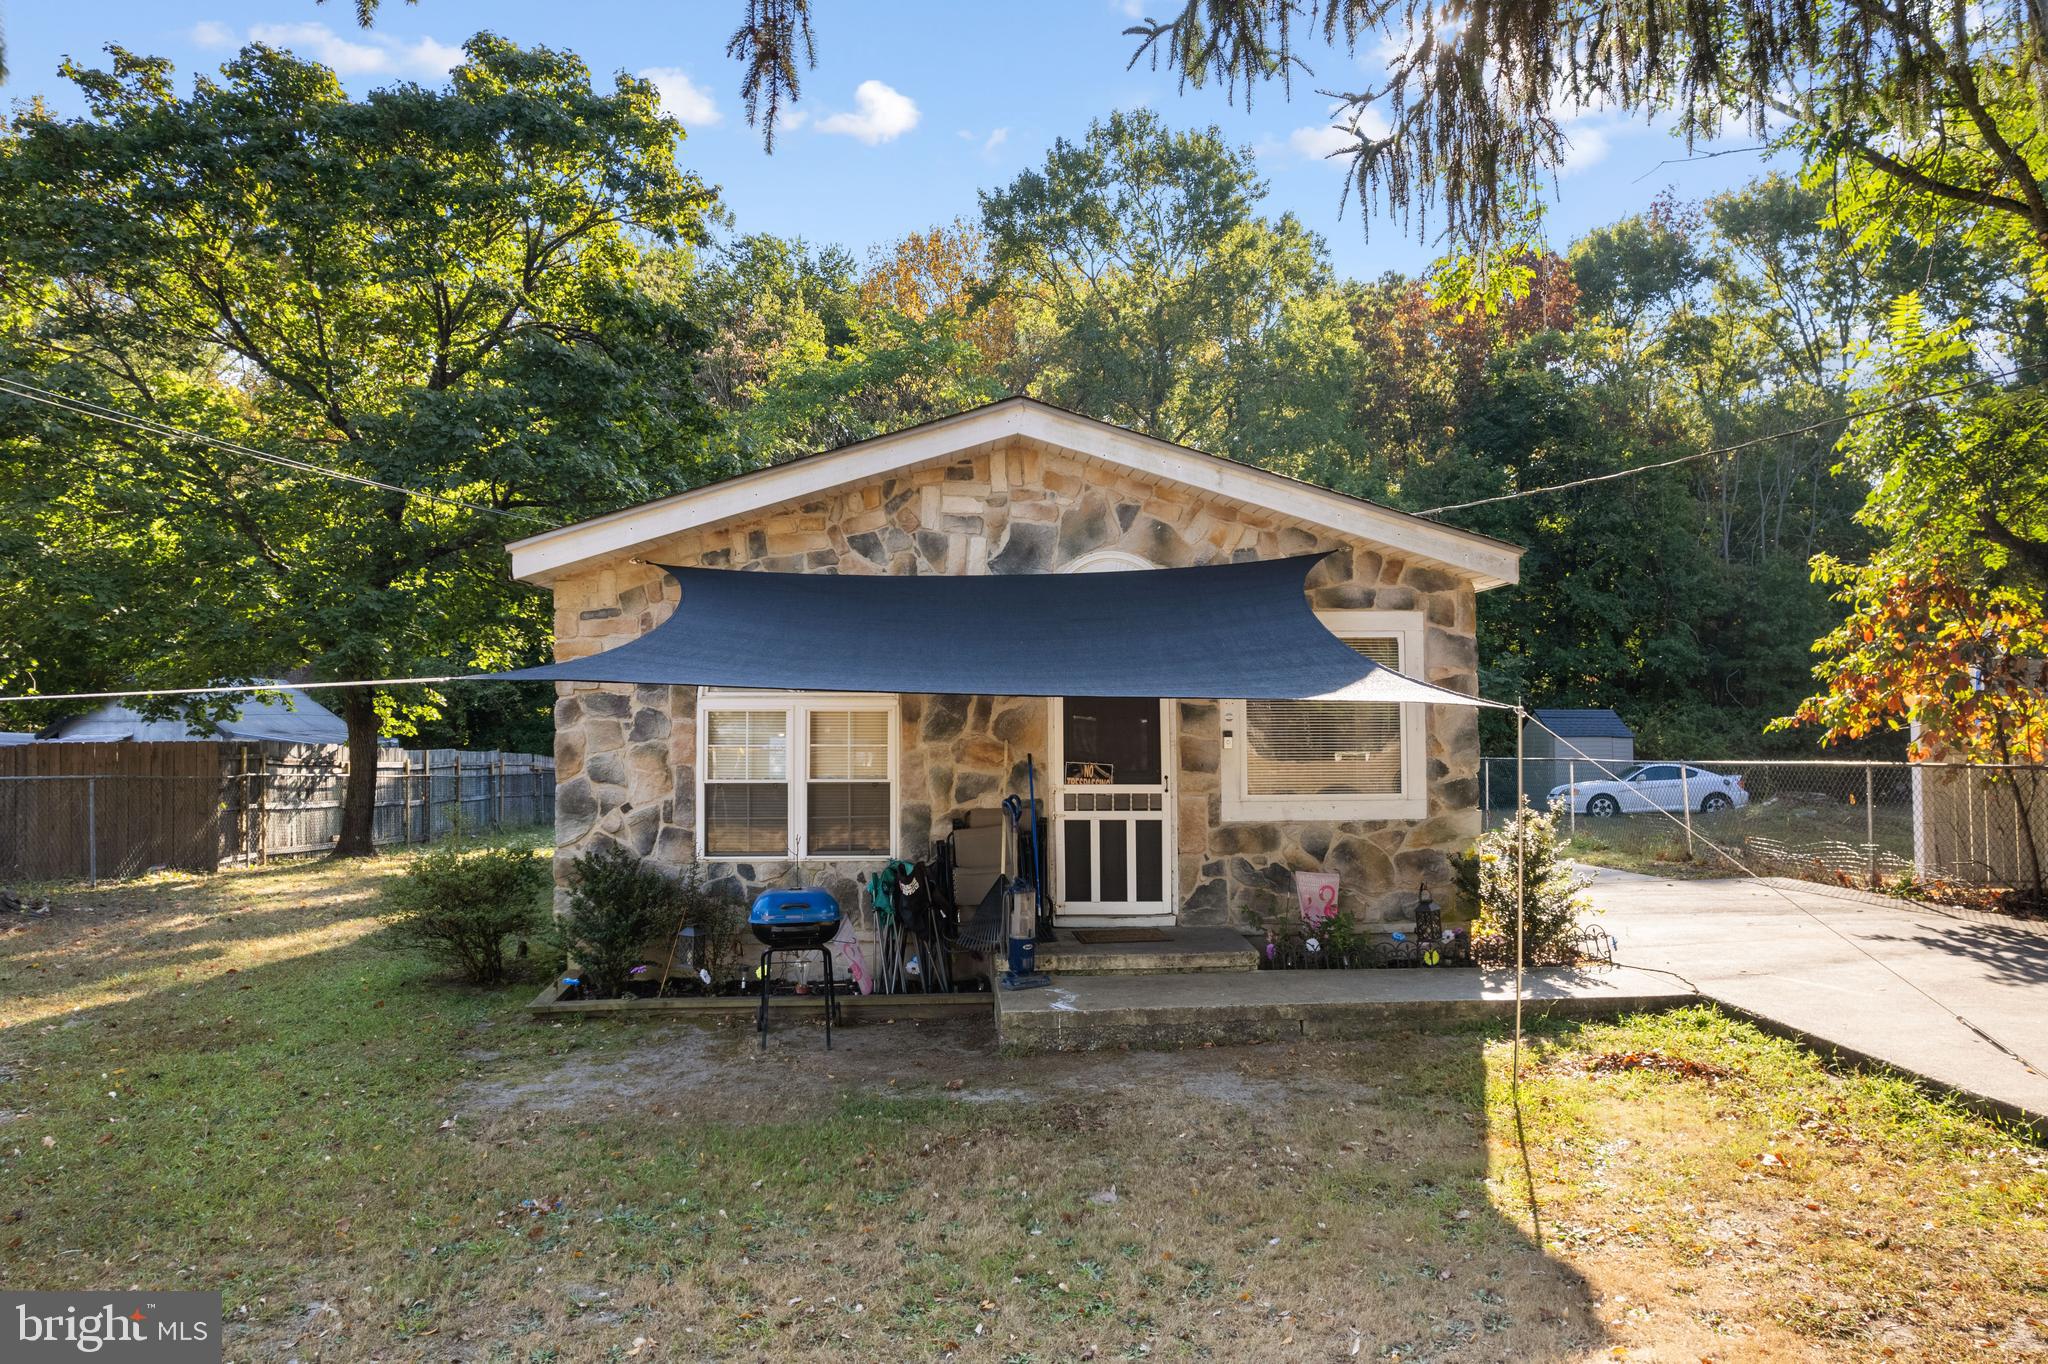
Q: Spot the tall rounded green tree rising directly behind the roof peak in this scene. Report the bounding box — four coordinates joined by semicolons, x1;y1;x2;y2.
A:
981;111;1354;463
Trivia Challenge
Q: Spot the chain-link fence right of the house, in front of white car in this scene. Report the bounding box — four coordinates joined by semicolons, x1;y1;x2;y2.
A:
1481;758;2048;887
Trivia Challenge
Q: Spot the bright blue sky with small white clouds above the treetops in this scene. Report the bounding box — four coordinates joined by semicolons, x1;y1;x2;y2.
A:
4;0;1765;279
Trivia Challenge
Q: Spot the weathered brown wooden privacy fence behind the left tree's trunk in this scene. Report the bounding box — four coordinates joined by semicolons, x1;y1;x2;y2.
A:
0;739;555;883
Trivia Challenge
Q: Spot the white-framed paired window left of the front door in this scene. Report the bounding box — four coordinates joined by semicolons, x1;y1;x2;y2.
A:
696;690;897;860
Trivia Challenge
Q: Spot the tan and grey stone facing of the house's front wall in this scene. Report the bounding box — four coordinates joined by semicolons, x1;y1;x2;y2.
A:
553;438;1479;926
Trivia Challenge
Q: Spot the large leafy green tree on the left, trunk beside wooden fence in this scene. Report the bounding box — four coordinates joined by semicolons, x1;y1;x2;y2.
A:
0;35;713;854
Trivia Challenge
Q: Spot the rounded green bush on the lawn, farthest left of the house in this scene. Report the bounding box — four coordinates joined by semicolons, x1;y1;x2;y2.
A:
385;844;549;985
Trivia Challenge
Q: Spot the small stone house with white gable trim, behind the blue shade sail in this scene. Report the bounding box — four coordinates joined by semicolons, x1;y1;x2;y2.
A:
510;397;1522;926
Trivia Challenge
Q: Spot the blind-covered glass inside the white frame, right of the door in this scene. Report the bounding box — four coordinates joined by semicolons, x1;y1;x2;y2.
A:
1245;635;1403;797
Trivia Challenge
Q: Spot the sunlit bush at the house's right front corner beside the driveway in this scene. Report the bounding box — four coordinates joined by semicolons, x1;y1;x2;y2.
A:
1454;809;1591;967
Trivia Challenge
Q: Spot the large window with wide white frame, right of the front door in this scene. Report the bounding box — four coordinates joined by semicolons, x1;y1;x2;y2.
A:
1223;610;1427;821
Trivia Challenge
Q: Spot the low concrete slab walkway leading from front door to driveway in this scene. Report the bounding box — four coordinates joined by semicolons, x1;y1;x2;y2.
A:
995;958;1698;1053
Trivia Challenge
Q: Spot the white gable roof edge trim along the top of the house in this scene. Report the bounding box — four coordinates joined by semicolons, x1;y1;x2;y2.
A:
506;397;1522;592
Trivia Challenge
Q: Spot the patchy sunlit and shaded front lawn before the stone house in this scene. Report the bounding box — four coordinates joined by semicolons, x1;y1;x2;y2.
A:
0;839;2048;1364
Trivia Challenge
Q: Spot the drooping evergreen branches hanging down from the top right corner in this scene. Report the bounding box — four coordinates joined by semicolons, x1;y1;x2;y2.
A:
1126;0;2048;266
